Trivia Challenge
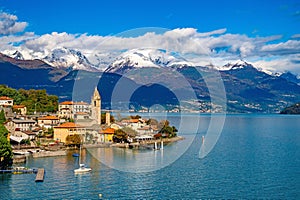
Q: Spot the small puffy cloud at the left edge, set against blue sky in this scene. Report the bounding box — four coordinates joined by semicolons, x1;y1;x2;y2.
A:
0;12;27;35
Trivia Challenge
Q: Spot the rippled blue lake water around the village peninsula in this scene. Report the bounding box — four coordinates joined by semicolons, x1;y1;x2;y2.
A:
0;114;300;199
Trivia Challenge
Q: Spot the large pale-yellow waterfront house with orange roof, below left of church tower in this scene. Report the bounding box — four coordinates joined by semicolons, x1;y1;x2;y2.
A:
53;122;86;143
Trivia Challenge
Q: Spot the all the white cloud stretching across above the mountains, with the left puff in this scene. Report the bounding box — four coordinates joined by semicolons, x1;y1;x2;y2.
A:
0;13;300;73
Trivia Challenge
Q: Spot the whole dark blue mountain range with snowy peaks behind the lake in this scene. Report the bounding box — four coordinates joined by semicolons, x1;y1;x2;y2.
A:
0;48;300;113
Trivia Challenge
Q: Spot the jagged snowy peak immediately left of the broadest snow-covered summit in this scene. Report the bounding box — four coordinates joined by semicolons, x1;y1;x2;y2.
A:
42;48;97;71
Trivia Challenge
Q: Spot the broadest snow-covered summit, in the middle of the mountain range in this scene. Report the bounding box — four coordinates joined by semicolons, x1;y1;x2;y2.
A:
105;49;193;73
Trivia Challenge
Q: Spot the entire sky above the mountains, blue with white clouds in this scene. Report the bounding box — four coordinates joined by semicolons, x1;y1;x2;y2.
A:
0;0;300;74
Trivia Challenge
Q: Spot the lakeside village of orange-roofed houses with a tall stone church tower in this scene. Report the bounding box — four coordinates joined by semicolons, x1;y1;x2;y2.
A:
0;88;177;160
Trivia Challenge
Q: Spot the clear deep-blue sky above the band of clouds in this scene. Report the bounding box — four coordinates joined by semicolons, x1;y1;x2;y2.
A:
0;0;300;37
